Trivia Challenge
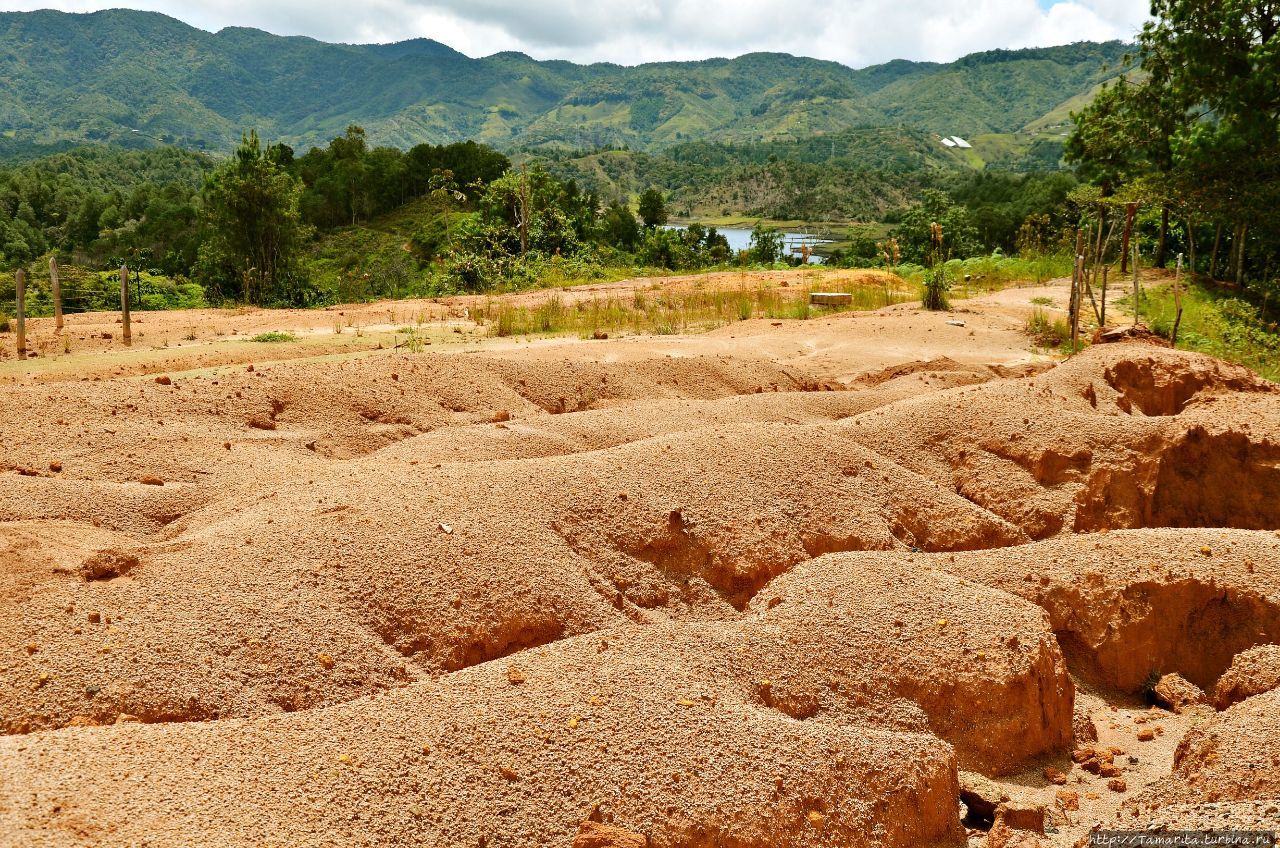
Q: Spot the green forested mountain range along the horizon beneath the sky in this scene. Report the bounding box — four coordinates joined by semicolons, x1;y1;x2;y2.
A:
0;10;1126;158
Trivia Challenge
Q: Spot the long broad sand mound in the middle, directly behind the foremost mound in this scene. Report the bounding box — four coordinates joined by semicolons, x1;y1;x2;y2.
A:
0;415;1021;730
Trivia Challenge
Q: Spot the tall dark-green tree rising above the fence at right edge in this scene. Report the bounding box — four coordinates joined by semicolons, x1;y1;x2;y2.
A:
1066;0;1280;277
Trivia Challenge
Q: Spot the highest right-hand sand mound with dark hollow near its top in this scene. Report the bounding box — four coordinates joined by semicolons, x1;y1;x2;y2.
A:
839;345;1280;538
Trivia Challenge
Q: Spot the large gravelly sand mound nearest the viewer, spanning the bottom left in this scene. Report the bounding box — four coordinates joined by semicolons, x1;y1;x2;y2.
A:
4;555;1073;845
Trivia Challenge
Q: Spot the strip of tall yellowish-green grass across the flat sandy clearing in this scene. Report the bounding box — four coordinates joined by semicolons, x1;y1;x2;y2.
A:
471;274;918;338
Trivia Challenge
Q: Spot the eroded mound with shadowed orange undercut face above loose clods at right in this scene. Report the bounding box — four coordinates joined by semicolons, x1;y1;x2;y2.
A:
926;529;1280;693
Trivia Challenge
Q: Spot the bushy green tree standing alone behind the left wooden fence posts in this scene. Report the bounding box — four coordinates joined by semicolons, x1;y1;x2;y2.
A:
198;131;308;305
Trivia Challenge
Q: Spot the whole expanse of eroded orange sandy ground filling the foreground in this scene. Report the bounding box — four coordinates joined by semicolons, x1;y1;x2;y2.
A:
0;272;1280;848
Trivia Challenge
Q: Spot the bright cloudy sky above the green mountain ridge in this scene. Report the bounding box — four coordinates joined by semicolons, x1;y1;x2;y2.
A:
0;0;1148;67
